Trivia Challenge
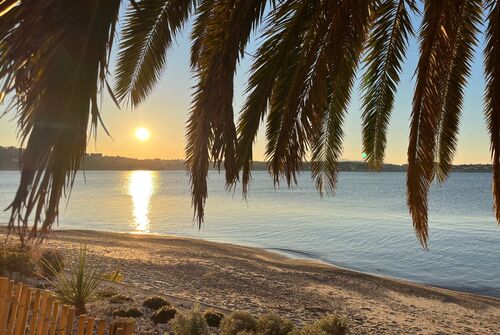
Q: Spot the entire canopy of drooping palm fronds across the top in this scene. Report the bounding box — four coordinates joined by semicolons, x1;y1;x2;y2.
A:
0;0;500;247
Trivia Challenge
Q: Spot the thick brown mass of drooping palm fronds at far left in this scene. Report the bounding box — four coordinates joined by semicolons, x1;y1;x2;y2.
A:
0;0;120;247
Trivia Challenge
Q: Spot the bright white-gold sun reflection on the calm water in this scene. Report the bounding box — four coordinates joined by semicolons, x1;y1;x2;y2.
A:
128;171;157;233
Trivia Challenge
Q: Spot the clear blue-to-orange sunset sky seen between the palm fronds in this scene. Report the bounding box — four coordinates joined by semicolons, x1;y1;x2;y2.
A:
0;9;490;164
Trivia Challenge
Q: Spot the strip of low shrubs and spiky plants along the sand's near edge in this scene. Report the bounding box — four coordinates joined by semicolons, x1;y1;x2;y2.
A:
0;245;348;335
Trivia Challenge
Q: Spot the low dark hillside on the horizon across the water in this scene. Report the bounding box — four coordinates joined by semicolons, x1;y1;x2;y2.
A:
0;147;491;172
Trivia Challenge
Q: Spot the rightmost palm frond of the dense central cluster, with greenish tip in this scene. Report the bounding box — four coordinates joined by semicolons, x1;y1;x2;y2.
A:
311;1;372;193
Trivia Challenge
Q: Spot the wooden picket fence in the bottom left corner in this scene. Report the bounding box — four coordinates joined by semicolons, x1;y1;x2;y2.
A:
0;277;135;335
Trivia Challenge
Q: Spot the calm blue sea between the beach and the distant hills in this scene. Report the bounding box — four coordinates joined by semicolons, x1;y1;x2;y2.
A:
0;171;500;297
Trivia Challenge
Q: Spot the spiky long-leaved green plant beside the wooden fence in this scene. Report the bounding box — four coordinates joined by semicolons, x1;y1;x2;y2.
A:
47;245;103;315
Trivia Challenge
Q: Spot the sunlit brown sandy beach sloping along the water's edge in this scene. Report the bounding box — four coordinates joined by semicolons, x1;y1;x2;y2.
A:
2;231;500;334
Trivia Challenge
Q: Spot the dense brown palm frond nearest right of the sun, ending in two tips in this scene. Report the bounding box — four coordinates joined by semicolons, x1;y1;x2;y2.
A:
186;0;267;225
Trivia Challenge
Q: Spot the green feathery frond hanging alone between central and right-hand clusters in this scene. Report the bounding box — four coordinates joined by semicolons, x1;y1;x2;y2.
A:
361;0;415;170
